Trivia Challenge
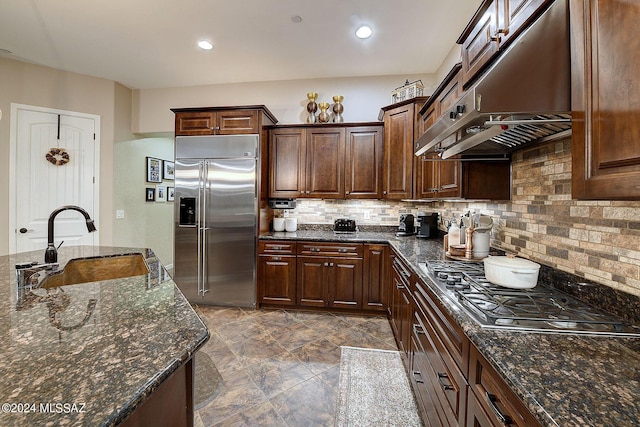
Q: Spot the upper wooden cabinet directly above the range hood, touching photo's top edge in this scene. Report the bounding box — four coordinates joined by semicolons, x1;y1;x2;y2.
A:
457;0;553;87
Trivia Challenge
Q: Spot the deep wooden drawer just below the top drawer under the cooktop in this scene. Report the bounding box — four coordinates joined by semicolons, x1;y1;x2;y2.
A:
411;309;467;425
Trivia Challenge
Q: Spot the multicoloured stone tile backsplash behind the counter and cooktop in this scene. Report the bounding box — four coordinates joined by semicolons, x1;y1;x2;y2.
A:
280;138;640;295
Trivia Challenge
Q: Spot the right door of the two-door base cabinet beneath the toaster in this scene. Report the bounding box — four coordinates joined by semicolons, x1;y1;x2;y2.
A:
328;258;362;309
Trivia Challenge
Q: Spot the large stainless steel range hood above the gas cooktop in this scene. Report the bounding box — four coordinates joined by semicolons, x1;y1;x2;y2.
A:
415;0;571;159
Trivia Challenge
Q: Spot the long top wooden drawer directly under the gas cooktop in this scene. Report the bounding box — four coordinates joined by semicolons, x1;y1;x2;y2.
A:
413;281;470;372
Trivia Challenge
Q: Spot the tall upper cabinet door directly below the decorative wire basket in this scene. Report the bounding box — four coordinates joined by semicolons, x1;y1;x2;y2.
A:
382;104;415;199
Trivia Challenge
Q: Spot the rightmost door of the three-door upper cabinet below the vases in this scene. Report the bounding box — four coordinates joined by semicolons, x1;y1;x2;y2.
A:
345;126;384;199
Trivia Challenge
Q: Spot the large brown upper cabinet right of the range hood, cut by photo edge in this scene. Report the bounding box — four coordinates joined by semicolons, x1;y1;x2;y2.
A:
570;0;640;200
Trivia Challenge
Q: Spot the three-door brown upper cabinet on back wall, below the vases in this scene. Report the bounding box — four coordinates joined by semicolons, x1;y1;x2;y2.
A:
269;123;383;199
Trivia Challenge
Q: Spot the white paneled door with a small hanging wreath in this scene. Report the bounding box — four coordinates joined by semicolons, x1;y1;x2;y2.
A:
10;105;100;261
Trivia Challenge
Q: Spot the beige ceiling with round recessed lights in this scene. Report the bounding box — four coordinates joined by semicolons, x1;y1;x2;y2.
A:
0;0;481;89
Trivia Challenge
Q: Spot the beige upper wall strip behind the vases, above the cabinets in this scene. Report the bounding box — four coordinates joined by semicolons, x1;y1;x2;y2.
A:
132;74;439;133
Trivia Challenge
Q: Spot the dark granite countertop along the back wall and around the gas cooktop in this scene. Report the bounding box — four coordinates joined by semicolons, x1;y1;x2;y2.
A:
261;231;640;426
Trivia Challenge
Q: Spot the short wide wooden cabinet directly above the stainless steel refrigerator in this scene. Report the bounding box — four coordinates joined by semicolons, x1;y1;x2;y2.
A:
171;105;277;136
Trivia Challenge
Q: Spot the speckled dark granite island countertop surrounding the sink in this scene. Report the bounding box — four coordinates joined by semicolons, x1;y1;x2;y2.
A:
0;246;209;426
